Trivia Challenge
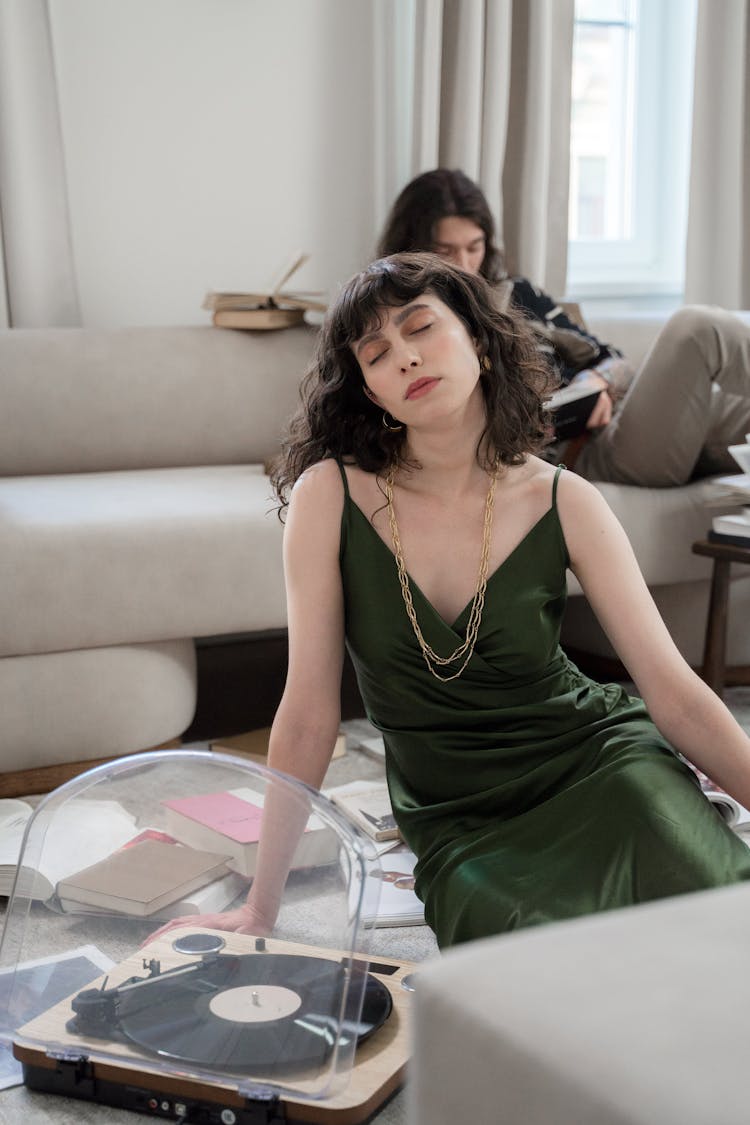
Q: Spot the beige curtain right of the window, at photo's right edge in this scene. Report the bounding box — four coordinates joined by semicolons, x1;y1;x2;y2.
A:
685;0;750;308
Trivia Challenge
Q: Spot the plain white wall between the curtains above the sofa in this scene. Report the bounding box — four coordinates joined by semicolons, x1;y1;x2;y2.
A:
49;0;378;325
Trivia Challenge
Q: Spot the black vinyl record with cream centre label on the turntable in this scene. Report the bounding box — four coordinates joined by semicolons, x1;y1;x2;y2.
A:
71;953;392;1074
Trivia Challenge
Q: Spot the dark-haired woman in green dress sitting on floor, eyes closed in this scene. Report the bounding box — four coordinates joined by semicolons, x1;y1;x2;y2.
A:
152;254;750;947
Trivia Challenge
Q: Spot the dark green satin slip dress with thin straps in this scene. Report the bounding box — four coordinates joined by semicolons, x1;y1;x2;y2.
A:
340;469;750;947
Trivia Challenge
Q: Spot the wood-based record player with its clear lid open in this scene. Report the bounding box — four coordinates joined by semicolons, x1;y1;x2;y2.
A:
1;750;414;1125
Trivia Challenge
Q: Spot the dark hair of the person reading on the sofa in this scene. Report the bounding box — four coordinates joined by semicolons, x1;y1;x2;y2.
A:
377;168;506;281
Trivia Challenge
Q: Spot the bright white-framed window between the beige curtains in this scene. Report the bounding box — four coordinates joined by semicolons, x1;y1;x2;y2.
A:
568;0;696;299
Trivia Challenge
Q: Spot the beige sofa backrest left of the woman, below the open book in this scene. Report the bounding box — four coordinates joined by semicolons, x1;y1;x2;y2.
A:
0;325;316;475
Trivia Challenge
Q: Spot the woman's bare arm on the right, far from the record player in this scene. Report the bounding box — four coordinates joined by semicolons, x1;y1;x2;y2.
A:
558;473;750;808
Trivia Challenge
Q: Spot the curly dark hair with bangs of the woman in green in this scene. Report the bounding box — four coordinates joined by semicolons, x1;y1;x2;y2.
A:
271;254;559;509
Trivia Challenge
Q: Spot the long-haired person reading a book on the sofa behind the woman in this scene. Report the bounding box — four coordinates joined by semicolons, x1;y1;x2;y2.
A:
378;168;750;487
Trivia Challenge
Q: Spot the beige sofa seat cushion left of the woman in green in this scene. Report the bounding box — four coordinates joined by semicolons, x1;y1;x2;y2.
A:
0;465;287;656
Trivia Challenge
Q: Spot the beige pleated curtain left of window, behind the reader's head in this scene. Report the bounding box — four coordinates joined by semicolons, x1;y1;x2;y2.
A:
384;0;573;295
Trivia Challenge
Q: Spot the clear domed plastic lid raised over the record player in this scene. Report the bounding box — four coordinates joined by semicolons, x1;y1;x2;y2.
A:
0;750;398;1121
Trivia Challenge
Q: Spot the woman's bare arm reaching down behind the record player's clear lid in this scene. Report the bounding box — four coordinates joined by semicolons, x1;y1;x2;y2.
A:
150;461;344;941
